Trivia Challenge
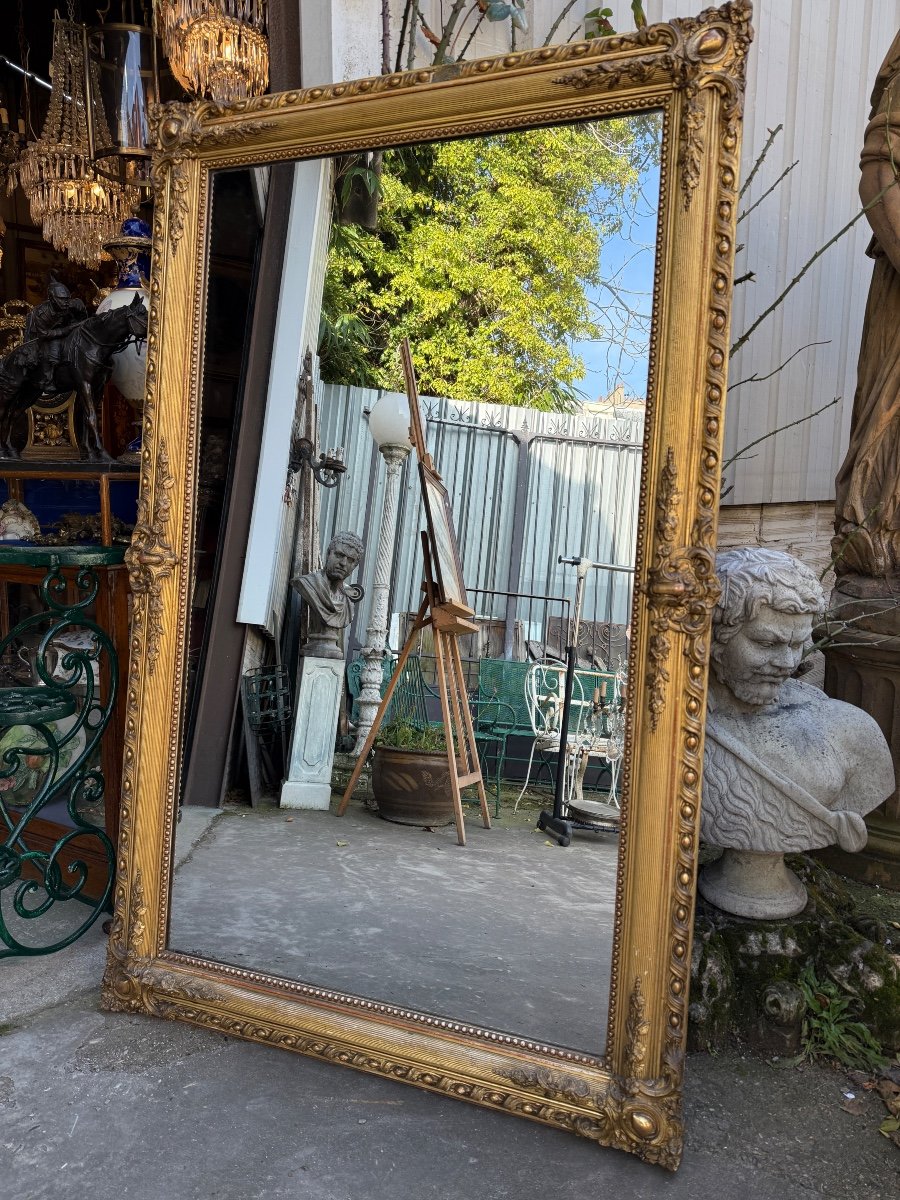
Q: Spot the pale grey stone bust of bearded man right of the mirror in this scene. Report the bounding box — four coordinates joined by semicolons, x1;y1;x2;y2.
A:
700;548;894;918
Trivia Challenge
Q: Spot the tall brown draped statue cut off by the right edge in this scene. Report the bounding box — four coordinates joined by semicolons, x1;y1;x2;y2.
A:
834;32;900;578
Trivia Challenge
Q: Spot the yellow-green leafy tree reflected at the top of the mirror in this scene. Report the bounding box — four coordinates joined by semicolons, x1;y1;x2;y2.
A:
320;116;656;409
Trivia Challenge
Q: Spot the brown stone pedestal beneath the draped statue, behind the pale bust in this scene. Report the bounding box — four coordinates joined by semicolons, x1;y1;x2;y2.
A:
817;575;900;889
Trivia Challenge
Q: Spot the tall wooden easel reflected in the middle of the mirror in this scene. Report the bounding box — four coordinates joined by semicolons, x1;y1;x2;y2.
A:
337;338;491;846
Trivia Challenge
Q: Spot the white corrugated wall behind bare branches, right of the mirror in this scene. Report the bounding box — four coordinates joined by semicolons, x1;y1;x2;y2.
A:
607;0;900;504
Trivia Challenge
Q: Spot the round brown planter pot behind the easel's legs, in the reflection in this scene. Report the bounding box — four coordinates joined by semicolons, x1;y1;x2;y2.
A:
372;746;454;827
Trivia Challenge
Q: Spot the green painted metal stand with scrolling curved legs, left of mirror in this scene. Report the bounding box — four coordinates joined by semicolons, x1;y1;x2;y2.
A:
0;545;124;959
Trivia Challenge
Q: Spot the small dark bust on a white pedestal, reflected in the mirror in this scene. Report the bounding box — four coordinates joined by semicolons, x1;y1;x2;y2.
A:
293;532;364;659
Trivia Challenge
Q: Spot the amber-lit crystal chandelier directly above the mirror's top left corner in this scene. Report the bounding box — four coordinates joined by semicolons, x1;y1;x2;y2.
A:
154;0;269;104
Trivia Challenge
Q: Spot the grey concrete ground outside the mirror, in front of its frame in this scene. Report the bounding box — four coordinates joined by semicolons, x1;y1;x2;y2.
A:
0;801;900;1200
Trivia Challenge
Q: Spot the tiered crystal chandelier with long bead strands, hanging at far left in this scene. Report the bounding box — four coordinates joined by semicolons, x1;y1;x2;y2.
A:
18;18;140;266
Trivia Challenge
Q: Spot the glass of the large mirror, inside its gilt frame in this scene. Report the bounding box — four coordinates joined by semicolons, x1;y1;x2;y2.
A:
168;112;662;1056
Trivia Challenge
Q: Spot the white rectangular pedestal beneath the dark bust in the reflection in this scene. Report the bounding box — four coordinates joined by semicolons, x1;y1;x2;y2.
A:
281;656;344;809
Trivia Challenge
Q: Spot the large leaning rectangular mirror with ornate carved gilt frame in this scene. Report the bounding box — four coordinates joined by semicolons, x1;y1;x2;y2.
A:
104;4;750;1168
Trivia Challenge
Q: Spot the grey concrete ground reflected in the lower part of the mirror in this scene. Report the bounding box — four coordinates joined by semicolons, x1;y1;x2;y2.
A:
169;805;618;1055
